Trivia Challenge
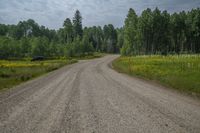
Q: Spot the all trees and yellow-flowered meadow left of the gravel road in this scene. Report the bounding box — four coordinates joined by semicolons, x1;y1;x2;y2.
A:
0;10;113;90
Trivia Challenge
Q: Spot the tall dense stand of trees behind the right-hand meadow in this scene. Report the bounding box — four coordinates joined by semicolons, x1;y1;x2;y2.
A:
121;8;200;55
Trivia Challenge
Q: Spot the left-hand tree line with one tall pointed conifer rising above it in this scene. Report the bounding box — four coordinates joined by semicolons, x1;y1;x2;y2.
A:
0;10;119;59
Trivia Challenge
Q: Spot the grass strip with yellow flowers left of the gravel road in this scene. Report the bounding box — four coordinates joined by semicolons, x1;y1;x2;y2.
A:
0;59;77;90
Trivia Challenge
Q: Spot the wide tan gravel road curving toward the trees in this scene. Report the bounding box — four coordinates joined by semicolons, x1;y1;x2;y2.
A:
0;55;200;133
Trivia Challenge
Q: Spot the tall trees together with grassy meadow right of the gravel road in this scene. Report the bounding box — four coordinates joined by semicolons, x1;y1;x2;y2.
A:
113;8;200;95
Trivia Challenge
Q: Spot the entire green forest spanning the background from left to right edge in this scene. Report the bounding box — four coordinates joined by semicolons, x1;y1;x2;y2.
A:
0;8;200;59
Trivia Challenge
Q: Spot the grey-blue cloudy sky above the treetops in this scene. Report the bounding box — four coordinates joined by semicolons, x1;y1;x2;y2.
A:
0;0;200;29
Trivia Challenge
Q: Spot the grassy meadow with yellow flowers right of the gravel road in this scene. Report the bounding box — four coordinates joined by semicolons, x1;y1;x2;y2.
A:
113;55;200;96
